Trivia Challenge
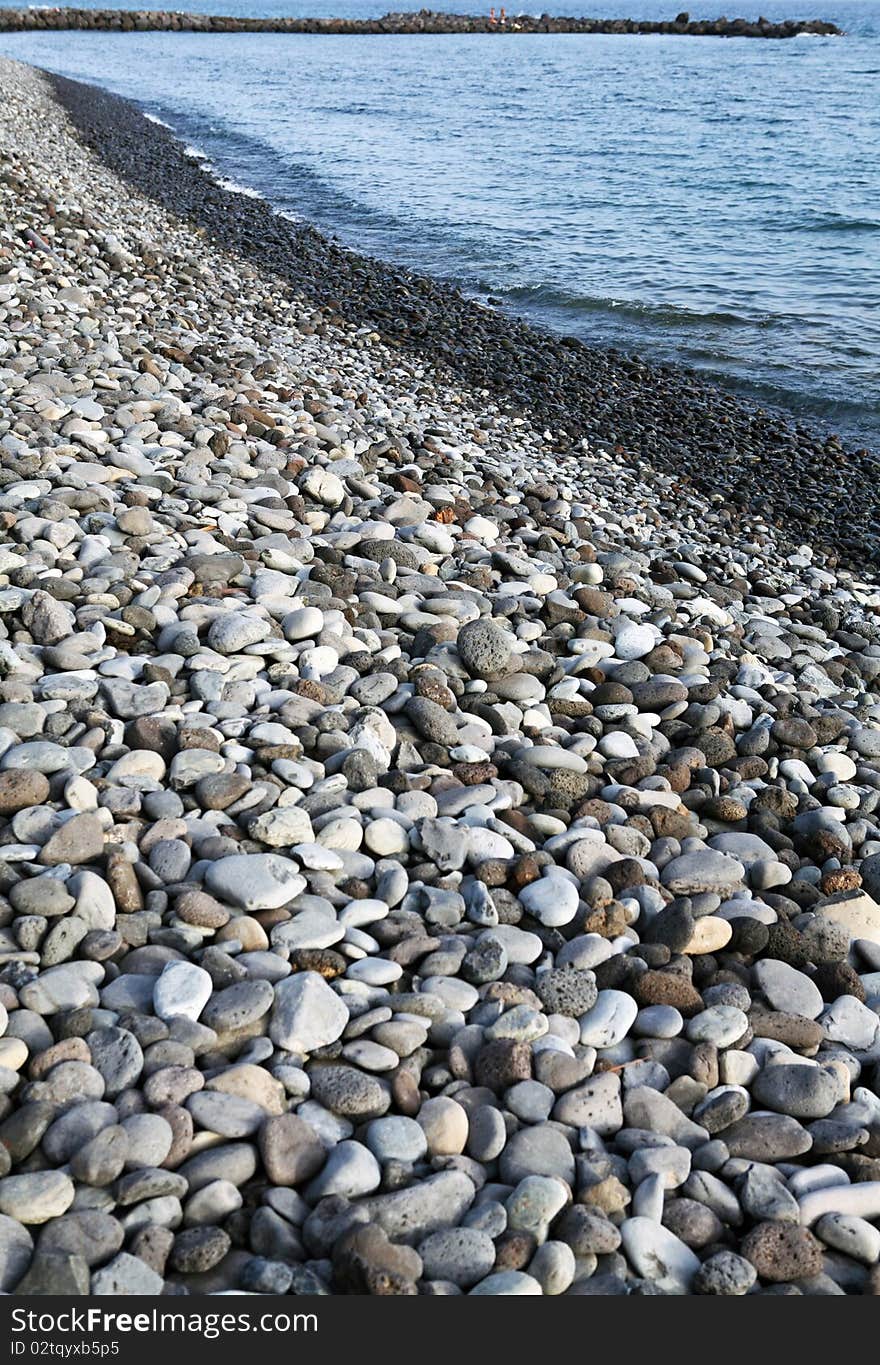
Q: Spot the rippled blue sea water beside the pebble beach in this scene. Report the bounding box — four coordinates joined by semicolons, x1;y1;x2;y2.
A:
0;0;880;446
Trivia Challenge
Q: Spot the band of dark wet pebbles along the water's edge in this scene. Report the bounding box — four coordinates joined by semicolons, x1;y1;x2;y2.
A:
42;60;880;572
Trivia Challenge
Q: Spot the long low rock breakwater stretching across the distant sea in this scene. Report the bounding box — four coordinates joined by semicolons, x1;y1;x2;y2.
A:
0;7;843;38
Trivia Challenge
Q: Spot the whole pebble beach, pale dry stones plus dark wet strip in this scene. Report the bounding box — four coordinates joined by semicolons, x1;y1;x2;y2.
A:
0;59;880;1297
